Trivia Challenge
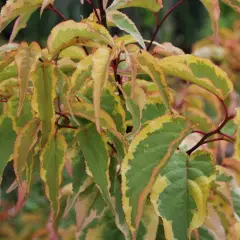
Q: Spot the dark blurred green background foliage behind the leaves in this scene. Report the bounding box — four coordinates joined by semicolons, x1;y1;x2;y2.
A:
0;0;239;240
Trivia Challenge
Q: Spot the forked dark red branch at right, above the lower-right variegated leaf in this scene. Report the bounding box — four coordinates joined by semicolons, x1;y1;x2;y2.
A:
187;98;235;155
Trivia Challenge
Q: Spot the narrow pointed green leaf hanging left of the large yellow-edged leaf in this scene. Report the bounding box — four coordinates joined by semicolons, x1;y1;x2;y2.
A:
77;125;112;209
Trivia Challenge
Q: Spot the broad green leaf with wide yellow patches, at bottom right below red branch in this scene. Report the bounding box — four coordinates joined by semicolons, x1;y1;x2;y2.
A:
151;151;215;240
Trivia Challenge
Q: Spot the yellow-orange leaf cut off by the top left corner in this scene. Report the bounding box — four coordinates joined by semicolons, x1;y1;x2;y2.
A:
0;0;42;32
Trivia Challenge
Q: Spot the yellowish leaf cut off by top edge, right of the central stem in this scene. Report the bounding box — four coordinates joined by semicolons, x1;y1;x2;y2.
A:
107;0;163;12
